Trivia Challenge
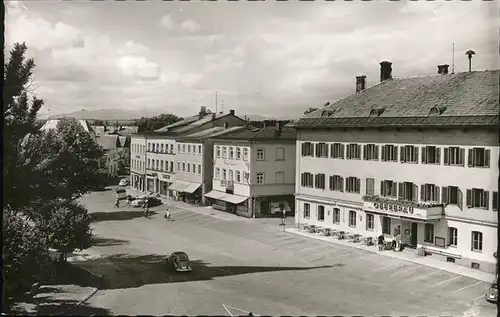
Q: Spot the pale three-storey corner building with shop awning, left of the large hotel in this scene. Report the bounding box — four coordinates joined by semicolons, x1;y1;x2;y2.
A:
205;124;296;217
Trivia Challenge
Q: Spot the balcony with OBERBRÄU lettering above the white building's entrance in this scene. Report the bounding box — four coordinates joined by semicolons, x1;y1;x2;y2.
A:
363;195;444;220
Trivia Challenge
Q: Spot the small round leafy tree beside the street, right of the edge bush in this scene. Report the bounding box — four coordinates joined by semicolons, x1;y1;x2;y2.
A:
36;200;92;260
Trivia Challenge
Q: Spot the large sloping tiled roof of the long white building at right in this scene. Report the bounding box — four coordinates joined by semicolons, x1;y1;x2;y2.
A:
293;70;500;127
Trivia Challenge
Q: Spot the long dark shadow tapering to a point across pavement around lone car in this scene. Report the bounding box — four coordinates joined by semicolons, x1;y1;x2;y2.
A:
75;254;331;289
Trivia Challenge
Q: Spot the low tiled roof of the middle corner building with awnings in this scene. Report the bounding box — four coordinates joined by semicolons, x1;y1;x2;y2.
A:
208;126;297;140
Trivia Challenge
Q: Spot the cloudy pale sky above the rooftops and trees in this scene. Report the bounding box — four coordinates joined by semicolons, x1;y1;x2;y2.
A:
5;1;500;117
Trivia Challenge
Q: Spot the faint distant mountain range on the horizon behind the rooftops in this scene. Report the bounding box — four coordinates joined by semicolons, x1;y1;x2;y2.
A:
43;109;293;121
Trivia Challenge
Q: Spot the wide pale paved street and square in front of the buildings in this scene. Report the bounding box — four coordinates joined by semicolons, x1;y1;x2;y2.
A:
75;191;496;316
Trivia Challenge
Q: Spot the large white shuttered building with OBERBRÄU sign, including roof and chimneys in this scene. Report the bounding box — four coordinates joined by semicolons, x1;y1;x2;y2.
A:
293;62;500;272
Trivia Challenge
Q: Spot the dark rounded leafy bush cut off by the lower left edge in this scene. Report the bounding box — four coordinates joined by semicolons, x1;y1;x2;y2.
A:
3;208;50;300
